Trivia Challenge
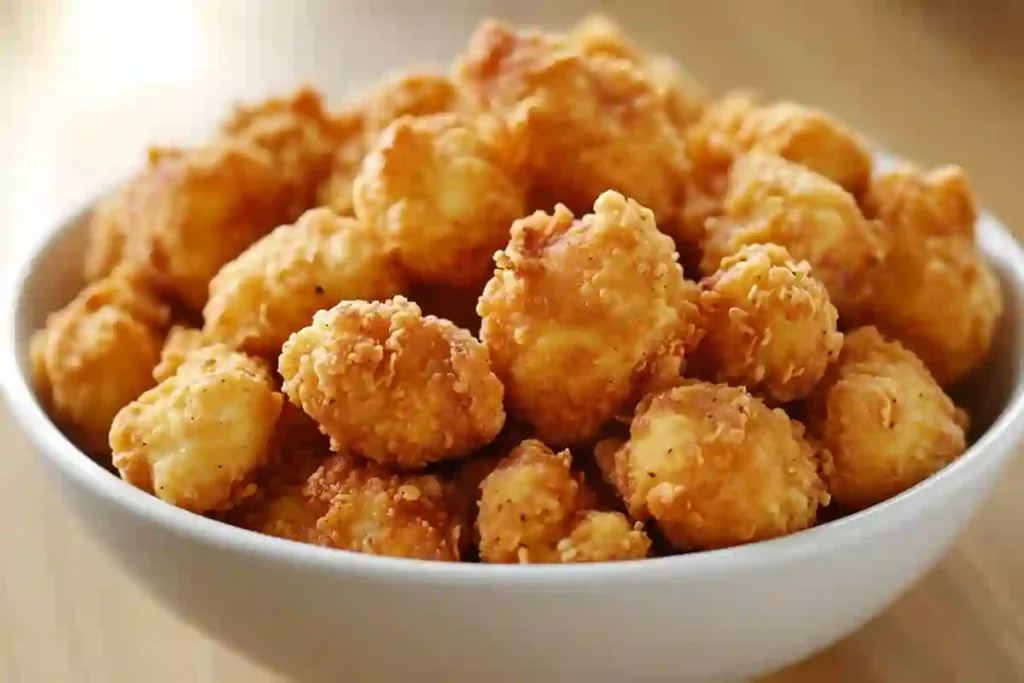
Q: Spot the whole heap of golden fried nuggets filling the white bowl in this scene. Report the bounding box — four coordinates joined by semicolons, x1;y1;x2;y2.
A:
32;17;1002;563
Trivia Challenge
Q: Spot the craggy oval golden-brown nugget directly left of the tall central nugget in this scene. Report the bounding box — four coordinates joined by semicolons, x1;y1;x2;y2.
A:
279;297;505;468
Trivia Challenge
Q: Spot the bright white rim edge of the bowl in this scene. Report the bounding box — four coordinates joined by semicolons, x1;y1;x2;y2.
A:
0;153;1024;588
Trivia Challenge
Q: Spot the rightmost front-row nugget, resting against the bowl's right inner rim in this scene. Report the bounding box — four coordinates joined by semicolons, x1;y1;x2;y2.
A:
807;327;966;509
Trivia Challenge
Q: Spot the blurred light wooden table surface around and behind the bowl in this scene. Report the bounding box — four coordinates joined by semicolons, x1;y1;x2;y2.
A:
0;0;1024;683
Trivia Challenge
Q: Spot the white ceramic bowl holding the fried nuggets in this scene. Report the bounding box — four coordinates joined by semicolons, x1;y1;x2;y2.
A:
0;178;1024;683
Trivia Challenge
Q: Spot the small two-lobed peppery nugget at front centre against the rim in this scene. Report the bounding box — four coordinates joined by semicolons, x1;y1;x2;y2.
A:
476;439;650;564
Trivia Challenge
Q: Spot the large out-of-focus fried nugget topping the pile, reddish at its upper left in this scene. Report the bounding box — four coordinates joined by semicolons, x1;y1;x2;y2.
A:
455;20;686;222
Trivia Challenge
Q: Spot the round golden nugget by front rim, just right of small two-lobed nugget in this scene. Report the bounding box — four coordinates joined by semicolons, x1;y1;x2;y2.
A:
597;382;828;550
